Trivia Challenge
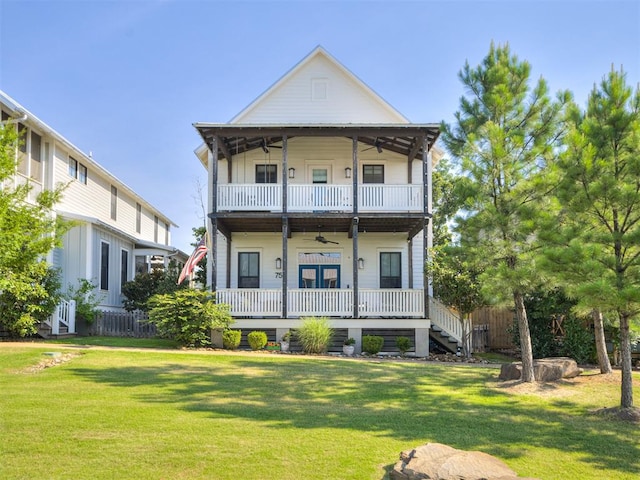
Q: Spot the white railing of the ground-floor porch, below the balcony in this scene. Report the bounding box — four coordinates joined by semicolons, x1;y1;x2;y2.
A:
216;288;424;318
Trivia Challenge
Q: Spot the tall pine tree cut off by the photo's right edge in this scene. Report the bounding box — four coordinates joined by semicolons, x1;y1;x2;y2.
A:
547;70;640;408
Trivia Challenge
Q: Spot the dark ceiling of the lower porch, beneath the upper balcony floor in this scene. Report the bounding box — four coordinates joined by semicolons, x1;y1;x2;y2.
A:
216;212;424;237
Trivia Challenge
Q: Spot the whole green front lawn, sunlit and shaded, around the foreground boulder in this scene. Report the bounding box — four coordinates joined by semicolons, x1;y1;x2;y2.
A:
0;343;640;480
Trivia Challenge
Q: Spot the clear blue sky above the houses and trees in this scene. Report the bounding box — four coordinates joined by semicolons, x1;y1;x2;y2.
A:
0;0;640;253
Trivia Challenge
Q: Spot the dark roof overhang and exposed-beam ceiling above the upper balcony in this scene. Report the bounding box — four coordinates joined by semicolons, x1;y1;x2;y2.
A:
193;123;440;159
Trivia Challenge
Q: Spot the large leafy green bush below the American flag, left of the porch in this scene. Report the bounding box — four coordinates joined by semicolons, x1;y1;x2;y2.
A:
149;289;233;347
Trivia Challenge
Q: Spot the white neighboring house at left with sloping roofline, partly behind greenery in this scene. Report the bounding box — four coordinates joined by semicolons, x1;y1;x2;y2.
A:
0;91;187;330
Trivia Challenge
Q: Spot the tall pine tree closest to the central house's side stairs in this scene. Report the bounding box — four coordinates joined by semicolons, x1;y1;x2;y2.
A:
442;43;568;382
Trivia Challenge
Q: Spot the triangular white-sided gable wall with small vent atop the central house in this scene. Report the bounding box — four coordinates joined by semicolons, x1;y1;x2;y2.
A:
232;54;407;124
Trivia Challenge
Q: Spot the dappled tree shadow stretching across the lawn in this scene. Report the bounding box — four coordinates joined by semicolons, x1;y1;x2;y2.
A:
70;356;640;473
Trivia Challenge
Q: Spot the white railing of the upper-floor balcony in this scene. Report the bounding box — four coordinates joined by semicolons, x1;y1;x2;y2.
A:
217;183;423;212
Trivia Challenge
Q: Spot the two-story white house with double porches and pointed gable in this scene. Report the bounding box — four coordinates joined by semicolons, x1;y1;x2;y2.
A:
194;47;459;356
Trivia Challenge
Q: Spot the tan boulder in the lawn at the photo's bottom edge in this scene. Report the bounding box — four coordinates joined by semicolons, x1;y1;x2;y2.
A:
390;443;536;480
